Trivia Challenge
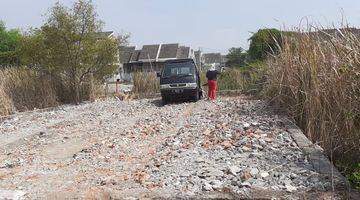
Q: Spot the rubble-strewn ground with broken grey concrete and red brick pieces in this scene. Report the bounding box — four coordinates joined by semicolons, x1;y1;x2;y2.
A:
0;97;342;199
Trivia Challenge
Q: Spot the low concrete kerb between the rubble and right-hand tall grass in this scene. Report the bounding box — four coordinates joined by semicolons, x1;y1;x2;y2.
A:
285;121;351;191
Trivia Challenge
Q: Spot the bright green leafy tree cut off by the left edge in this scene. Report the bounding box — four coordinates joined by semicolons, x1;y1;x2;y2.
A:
0;21;21;66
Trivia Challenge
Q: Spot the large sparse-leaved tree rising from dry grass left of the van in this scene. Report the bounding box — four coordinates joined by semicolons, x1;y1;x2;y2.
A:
22;0;119;103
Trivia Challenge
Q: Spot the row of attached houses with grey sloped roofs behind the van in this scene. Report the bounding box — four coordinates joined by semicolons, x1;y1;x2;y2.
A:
119;43;195;81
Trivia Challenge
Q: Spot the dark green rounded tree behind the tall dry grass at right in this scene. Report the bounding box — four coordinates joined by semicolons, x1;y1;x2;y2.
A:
248;29;282;61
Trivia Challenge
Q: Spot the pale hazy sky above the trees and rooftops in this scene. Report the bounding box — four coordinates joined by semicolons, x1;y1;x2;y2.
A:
0;0;360;53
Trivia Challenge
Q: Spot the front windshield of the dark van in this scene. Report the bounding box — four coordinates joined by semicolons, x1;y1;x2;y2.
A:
162;62;195;77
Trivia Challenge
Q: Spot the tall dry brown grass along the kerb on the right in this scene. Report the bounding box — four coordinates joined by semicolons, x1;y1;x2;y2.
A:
266;26;360;162
